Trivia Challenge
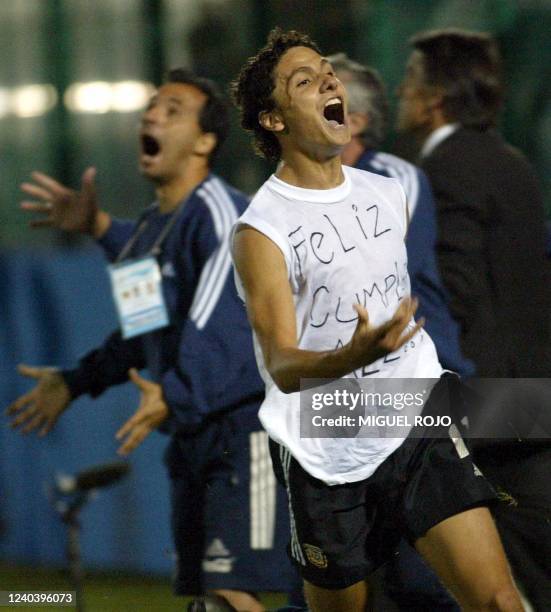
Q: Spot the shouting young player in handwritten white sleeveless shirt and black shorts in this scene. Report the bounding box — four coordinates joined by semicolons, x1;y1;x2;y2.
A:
233;30;522;612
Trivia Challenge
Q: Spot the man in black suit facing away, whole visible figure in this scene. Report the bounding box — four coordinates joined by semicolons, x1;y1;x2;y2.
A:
398;30;551;610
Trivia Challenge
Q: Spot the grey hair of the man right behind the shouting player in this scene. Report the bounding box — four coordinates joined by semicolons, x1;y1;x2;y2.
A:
327;53;388;149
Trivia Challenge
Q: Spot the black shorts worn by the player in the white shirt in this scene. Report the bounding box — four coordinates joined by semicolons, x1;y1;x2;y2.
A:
270;377;496;589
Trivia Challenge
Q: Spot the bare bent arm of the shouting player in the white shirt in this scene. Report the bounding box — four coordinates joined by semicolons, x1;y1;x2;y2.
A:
234;226;423;393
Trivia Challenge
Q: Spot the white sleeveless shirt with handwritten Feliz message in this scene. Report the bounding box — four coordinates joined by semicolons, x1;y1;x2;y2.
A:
236;166;442;485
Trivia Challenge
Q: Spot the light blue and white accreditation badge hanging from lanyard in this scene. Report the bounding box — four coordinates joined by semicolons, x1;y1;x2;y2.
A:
108;256;169;340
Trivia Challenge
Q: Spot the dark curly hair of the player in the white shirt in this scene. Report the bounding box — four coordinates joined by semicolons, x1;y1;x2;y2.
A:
230;28;320;161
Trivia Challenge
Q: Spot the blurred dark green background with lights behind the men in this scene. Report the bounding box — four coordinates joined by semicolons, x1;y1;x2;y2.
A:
0;0;551;247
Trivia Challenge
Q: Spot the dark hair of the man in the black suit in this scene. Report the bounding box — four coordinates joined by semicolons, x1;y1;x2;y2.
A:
410;28;503;129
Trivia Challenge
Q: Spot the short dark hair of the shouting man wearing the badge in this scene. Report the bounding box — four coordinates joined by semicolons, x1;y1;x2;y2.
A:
166;68;230;163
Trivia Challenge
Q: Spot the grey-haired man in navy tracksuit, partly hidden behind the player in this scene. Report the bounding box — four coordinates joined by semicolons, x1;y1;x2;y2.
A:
328;53;474;612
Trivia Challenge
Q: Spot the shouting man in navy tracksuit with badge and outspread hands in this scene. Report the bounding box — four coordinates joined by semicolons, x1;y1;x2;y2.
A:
9;70;292;612
